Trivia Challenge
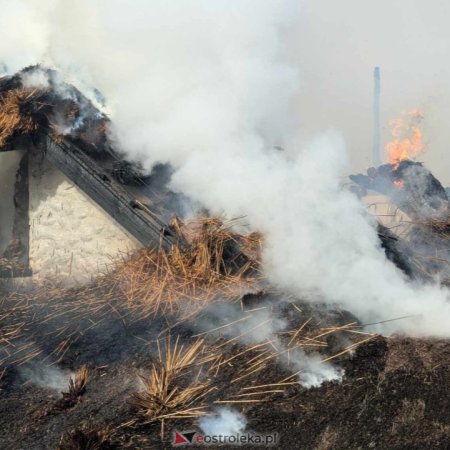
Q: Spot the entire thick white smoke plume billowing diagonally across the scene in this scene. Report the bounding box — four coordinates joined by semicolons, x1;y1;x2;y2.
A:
0;0;450;336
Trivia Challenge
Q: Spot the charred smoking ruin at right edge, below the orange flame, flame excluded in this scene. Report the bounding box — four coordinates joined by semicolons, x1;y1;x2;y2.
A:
349;160;450;284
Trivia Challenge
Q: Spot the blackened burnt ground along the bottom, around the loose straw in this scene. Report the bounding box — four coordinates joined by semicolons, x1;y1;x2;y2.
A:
0;284;450;450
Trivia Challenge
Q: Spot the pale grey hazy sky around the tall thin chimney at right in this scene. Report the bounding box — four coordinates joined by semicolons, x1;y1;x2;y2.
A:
292;0;450;184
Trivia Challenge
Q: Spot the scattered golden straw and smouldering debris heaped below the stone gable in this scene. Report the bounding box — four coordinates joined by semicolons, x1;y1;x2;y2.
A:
3;219;373;446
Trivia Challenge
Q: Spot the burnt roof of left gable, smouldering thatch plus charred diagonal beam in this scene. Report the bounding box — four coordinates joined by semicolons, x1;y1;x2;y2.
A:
0;66;176;266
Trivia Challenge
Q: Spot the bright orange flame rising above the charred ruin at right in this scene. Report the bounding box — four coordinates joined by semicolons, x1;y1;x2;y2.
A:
385;109;424;165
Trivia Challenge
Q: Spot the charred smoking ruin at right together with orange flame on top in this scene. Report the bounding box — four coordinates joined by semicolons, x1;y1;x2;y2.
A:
349;109;450;284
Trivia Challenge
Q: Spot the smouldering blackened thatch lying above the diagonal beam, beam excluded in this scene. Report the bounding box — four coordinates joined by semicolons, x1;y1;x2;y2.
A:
0;66;193;222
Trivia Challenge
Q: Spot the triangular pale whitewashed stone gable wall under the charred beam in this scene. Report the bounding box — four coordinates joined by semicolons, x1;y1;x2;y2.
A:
29;152;139;285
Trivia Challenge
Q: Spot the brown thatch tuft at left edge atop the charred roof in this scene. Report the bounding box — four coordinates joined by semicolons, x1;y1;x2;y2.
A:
0;88;38;148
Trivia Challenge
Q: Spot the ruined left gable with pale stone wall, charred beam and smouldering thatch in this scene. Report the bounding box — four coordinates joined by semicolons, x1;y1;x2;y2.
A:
0;67;183;283
